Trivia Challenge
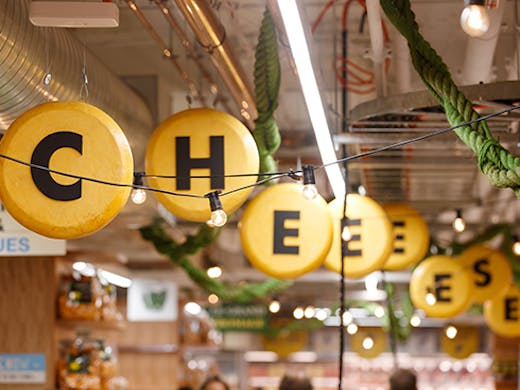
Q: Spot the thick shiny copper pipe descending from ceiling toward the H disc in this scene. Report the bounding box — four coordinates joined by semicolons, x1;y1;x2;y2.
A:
175;0;258;129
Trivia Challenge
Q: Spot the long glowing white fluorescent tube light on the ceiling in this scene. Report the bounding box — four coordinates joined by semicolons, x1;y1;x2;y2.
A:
278;0;345;199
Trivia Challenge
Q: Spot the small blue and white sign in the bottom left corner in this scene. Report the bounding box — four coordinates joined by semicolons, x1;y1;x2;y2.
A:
0;353;46;383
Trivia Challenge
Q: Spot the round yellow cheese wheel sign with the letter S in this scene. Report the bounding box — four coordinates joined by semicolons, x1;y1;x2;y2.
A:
458;245;513;303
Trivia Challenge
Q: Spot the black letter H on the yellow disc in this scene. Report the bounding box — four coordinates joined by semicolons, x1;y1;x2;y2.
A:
175;135;224;190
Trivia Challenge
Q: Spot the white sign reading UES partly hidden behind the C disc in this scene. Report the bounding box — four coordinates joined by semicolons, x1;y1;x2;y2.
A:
0;203;66;256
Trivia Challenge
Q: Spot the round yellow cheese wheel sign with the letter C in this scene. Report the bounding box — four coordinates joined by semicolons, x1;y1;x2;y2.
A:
0;102;133;238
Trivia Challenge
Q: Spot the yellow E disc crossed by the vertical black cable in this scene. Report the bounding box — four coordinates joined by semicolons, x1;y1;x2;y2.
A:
324;194;393;278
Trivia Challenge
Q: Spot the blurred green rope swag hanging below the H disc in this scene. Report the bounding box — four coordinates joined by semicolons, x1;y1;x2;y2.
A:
139;220;292;303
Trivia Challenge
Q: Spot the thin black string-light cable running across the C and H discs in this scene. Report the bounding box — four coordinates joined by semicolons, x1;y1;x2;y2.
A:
0;105;520;199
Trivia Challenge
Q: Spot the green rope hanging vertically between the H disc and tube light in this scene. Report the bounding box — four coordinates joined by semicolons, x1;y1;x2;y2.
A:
253;8;281;180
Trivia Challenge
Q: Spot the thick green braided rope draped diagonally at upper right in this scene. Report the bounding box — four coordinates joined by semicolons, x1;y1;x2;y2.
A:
380;0;520;198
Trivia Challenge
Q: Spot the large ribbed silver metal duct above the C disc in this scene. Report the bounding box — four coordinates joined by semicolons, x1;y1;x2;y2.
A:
0;0;154;168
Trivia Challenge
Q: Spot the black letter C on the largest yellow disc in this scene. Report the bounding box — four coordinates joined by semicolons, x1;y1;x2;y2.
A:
31;131;83;201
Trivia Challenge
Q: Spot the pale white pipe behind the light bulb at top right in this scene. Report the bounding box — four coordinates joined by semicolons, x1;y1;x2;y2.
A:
461;1;506;85
